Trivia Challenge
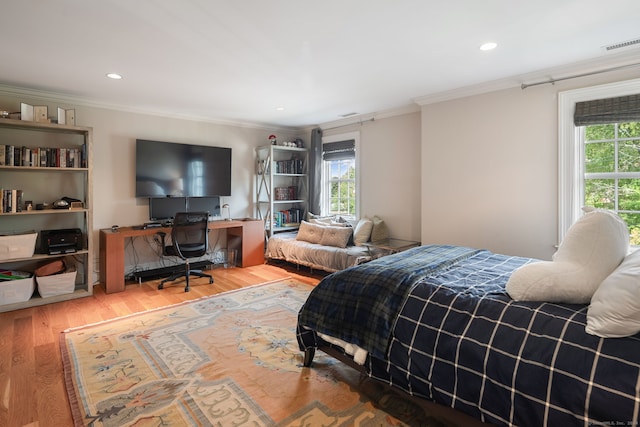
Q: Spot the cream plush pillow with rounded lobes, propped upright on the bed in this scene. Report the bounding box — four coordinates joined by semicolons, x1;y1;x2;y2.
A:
506;210;629;304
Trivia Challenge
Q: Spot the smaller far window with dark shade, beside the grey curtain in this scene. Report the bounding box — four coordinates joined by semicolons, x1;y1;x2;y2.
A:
320;133;359;219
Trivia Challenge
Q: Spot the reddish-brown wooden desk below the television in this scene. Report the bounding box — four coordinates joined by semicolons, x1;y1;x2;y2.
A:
100;219;264;294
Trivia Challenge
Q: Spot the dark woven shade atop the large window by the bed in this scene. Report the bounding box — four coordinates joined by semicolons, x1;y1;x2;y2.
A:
573;94;640;126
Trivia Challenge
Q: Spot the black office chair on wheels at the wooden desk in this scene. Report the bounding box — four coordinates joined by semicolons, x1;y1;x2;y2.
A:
158;212;213;292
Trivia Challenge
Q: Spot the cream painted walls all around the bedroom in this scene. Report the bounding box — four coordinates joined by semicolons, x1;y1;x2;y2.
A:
5;61;637;271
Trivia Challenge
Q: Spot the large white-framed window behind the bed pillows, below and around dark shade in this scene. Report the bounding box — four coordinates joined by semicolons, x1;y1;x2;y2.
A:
558;79;640;245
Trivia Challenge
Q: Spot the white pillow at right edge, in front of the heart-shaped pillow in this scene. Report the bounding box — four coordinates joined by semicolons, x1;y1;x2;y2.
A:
585;250;640;338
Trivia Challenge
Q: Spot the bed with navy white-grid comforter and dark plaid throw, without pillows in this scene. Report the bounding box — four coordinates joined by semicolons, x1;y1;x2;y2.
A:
297;236;640;426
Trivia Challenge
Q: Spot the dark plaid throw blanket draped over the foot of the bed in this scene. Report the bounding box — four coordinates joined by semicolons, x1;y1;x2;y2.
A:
298;245;479;359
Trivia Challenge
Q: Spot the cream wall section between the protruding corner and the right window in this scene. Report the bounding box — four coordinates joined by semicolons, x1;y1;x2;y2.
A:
421;67;637;259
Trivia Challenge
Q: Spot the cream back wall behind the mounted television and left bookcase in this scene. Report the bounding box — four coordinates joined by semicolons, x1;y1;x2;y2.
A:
0;90;308;280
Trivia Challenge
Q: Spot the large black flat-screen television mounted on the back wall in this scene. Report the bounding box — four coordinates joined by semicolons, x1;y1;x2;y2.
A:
136;139;231;197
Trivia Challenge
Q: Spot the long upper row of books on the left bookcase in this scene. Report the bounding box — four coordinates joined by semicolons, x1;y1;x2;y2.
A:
0;144;87;168
